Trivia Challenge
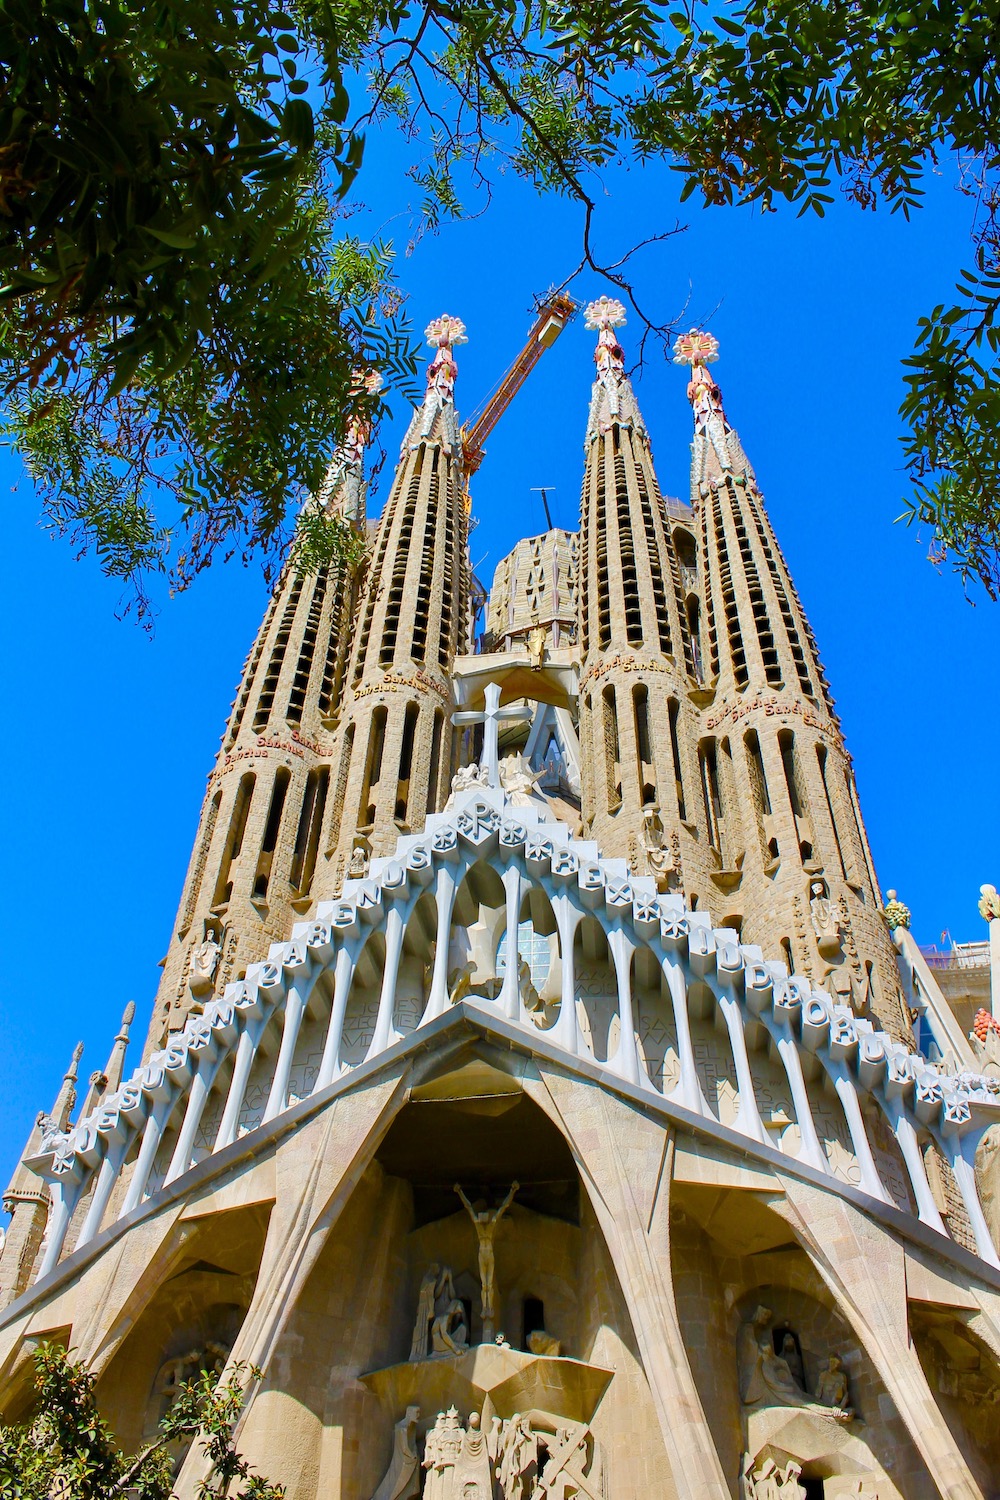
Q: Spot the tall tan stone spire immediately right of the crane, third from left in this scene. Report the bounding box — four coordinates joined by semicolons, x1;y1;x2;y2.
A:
580;297;699;888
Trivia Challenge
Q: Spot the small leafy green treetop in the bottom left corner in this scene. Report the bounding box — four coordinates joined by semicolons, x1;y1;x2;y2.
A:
0;1344;285;1500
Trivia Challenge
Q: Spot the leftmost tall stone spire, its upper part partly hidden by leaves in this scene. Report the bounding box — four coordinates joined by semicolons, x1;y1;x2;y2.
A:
145;381;374;1055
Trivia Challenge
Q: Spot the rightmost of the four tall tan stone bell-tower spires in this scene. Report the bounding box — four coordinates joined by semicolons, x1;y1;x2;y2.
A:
675;329;910;1041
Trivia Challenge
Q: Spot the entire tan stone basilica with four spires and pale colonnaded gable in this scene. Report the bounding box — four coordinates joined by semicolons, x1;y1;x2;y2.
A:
0;297;1000;1500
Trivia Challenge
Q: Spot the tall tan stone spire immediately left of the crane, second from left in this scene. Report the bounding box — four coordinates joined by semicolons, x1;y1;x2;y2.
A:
319;314;471;896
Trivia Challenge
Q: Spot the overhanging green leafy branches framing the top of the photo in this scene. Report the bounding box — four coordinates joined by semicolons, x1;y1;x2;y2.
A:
0;0;1000;597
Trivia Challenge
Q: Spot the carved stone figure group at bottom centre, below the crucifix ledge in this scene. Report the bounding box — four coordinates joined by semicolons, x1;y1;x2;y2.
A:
372;1404;606;1500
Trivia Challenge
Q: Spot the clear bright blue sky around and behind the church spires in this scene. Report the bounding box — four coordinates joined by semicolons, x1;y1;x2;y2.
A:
0;143;1000;1185
